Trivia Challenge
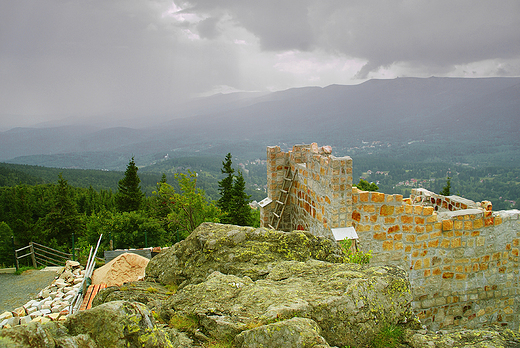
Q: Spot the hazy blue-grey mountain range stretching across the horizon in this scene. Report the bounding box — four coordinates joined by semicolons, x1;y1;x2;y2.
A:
0;77;520;169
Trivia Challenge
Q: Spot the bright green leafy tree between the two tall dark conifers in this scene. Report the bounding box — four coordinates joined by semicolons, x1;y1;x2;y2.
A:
154;172;221;236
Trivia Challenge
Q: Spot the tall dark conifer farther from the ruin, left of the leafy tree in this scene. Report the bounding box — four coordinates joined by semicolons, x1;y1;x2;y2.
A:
116;157;144;212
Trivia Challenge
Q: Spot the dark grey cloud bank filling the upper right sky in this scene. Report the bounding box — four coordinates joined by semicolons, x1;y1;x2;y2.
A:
192;0;520;78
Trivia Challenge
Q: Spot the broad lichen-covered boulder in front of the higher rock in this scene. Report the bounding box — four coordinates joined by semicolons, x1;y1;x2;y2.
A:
161;260;417;347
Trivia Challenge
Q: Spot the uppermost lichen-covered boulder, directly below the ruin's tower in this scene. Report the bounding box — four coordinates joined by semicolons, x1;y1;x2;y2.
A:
146;223;344;288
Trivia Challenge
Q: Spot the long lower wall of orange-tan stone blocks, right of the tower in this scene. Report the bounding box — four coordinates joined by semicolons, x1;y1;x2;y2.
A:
352;188;520;330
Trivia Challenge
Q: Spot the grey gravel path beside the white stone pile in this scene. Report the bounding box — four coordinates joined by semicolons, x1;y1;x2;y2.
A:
0;270;57;314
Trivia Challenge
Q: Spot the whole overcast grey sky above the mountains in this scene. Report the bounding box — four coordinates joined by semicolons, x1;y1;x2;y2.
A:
0;0;520;127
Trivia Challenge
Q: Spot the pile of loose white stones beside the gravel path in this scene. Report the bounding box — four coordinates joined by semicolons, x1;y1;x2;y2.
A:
0;260;85;328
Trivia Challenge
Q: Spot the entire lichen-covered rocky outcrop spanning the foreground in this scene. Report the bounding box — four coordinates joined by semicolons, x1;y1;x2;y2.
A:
0;223;520;348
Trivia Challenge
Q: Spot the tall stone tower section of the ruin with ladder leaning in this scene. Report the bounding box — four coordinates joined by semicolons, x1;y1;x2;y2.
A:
261;143;352;237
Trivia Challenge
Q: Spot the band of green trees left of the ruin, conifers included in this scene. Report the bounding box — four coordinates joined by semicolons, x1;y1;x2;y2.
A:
0;154;259;265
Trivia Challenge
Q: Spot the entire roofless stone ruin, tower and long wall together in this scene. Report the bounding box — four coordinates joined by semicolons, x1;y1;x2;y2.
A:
260;143;520;330
